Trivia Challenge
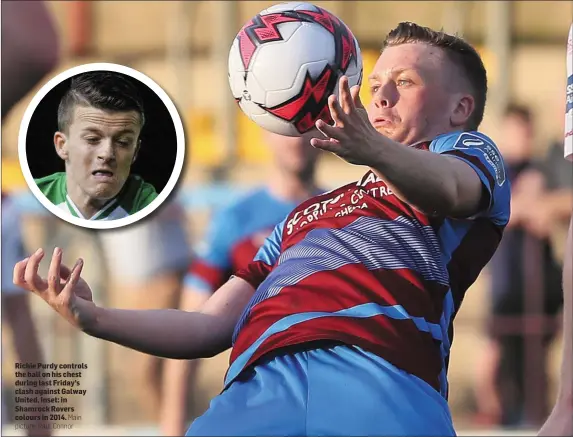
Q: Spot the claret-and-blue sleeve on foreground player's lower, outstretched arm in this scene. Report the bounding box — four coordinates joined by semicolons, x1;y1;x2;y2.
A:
235;219;286;289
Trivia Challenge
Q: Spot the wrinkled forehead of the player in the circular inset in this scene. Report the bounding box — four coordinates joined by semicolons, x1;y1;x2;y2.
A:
71;105;141;133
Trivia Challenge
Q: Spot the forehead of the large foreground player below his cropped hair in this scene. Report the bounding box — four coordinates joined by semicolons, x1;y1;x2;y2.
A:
369;43;447;79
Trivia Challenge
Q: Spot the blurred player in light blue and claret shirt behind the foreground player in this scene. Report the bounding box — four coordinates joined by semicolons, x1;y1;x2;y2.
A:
161;131;321;436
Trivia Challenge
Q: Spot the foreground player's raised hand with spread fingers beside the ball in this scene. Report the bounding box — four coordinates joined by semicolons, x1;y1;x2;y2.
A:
310;76;381;165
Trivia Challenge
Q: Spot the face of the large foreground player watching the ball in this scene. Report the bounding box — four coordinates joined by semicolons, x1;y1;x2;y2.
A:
368;43;474;145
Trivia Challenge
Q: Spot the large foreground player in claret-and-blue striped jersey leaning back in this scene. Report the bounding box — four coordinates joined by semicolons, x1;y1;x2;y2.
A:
14;23;510;436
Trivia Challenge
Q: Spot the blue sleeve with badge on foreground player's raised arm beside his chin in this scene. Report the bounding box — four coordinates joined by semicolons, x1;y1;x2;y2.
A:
430;132;511;226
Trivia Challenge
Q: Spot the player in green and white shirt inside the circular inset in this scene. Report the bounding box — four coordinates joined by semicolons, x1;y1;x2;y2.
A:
36;71;157;220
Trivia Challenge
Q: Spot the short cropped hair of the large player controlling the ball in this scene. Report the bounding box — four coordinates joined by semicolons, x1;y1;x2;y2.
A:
382;22;487;130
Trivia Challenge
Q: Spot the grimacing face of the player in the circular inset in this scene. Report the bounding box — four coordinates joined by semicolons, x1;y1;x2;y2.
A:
55;106;141;201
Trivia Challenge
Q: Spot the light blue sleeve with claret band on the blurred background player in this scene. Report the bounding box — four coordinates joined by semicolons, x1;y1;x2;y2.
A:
184;209;237;293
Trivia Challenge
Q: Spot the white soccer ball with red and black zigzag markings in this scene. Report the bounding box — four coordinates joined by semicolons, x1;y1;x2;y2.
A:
229;3;362;136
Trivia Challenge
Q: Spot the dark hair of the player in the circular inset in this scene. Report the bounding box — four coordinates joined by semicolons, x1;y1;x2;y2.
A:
58;71;145;132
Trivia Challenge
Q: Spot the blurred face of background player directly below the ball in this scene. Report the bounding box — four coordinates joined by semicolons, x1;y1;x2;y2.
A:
265;132;319;177
